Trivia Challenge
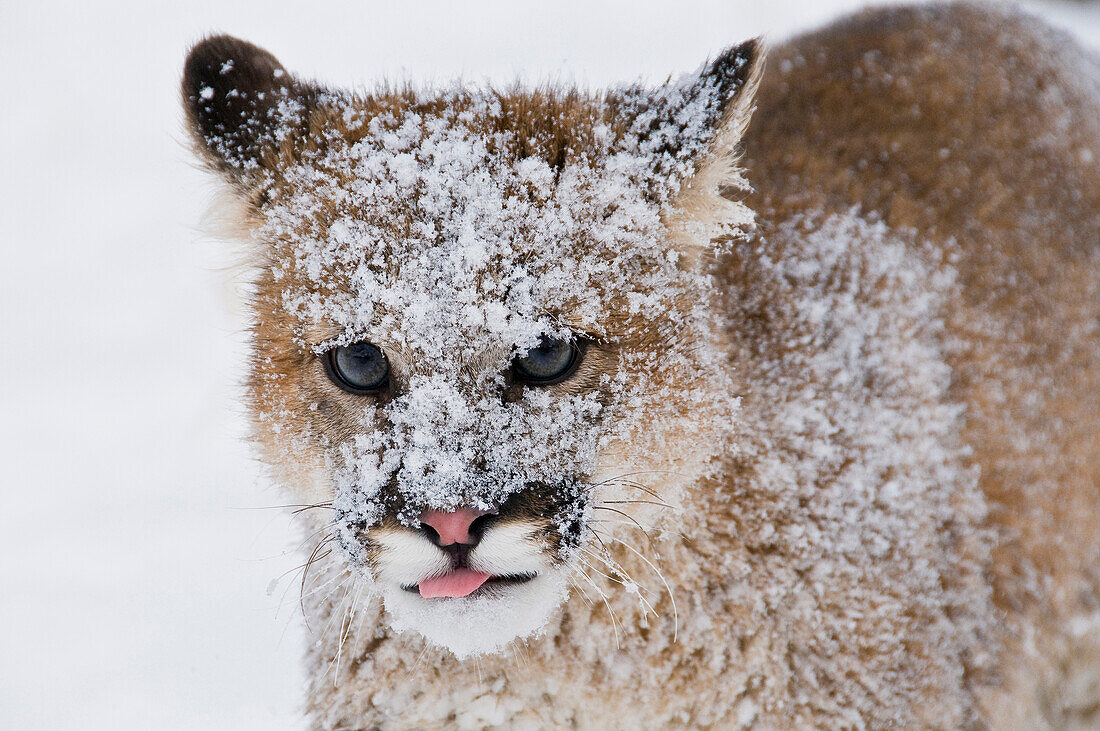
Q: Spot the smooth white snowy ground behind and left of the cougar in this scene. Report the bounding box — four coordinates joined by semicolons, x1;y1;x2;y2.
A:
0;0;1100;729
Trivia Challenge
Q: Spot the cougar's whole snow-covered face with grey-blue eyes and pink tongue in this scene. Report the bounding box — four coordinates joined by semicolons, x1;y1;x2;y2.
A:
185;34;761;656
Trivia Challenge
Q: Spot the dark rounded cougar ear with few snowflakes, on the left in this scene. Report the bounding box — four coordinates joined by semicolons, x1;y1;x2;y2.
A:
182;35;316;185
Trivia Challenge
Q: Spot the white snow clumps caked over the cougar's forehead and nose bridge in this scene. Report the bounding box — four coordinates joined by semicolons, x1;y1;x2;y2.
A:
256;77;749;540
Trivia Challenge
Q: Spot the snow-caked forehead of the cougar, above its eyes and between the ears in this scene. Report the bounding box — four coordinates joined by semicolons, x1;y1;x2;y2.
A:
261;100;685;350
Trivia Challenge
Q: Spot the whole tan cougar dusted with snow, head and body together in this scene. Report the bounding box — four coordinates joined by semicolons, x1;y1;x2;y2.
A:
184;5;1100;729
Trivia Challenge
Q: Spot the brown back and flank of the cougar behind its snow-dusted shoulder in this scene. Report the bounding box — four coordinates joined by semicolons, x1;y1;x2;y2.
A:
745;5;1100;728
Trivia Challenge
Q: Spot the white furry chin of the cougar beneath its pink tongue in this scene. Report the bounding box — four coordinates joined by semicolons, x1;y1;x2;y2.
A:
383;568;568;660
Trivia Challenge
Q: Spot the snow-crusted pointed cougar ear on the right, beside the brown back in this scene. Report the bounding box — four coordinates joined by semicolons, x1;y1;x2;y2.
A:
620;38;763;198
